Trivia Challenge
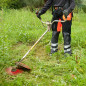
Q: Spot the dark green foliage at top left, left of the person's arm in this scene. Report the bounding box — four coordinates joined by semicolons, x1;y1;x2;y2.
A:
0;0;43;8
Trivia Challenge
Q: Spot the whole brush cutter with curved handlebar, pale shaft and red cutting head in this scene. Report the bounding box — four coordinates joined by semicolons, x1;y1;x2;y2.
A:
6;20;65;75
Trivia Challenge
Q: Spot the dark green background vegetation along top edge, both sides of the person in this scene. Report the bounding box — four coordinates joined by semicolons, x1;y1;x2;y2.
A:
0;0;86;12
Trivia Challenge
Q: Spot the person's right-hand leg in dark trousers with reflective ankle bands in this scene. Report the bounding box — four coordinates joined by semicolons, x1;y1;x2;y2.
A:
62;21;72;55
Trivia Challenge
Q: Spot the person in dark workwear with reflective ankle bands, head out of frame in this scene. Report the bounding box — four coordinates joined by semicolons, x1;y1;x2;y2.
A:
37;0;75;55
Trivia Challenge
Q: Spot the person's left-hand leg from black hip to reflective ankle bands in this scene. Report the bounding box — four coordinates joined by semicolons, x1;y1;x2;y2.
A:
51;9;63;54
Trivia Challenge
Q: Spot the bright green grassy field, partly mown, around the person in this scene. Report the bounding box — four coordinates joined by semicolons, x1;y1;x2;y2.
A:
0;9;86;86
